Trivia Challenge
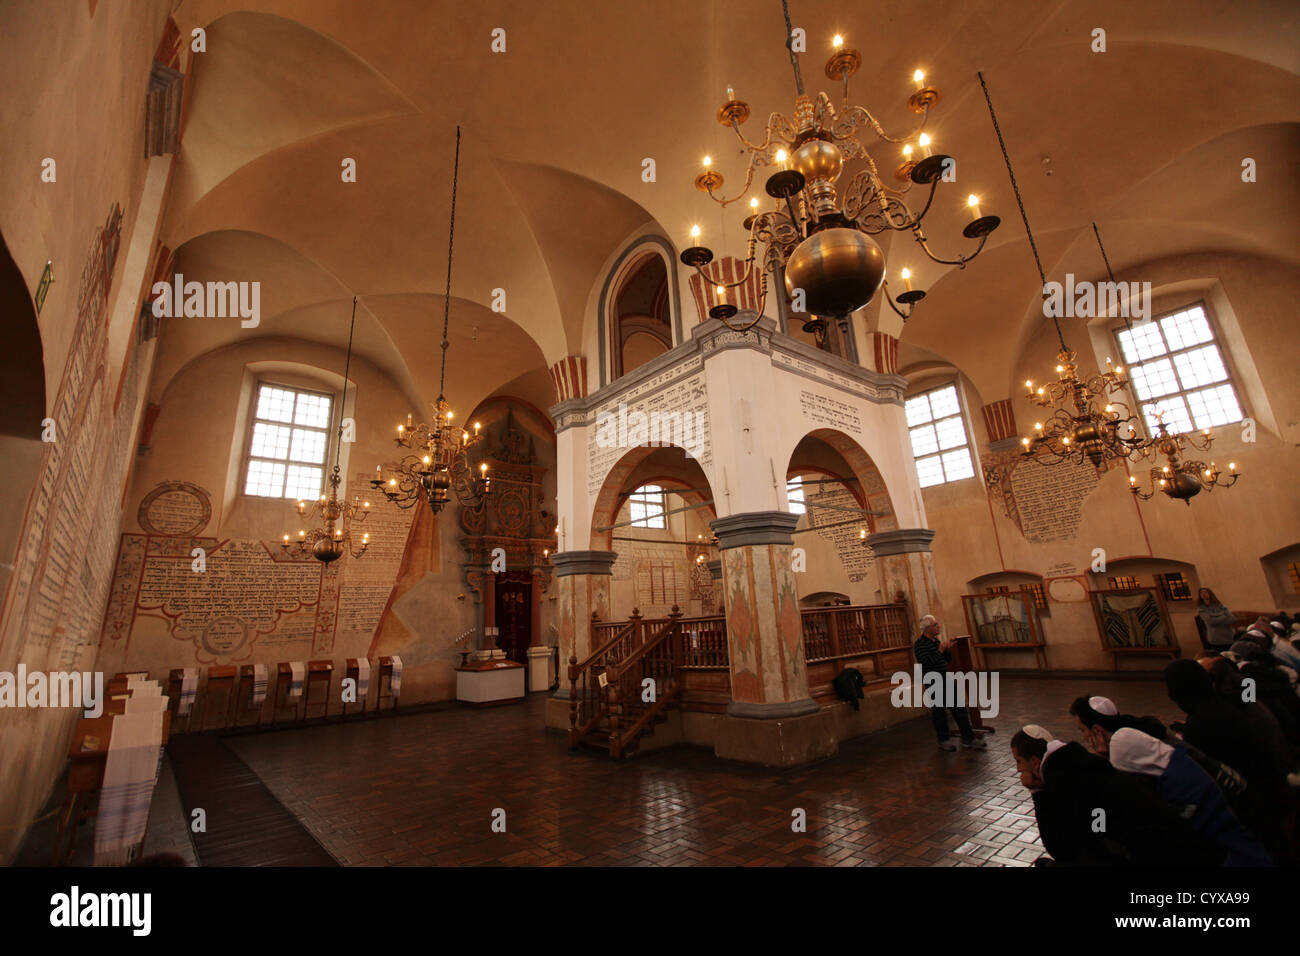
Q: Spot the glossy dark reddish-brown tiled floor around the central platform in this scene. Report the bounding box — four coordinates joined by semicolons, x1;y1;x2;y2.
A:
192;678;1178;866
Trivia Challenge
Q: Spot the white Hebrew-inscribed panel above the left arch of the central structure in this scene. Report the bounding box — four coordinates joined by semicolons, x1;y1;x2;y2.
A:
586;369;714;497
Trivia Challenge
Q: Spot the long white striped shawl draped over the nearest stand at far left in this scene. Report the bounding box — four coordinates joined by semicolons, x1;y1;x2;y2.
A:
95;712;166;866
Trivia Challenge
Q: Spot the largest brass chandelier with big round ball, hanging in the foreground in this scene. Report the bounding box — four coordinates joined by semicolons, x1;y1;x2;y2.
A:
681;0;1000;341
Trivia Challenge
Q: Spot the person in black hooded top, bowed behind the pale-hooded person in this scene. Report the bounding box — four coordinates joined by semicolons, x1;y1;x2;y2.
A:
1165;661;1287;861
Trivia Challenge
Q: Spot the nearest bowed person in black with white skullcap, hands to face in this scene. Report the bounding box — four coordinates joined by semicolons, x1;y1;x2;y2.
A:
1011;731;1223;866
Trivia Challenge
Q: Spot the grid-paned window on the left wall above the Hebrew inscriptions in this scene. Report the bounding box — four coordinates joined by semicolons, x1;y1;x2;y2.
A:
244;382;334;501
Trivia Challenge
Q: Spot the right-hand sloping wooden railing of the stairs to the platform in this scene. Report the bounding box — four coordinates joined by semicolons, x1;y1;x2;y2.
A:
607;605;681;757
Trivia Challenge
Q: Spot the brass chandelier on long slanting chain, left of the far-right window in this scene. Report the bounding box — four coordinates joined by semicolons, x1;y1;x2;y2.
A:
979;73;1145;471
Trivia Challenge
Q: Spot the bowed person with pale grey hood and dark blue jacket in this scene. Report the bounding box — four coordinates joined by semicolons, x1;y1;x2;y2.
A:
1110;727;1273;866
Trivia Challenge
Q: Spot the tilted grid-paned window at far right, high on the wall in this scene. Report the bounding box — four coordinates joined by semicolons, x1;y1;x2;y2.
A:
1115;303;1244;433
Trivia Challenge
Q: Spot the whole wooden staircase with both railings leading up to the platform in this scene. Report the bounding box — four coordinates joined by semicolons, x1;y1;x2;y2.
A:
568;605;683;757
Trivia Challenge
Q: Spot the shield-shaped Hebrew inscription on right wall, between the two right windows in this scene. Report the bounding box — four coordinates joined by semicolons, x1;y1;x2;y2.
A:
982;450;1100;544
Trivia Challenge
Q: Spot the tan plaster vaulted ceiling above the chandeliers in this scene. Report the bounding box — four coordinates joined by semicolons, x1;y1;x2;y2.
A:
160;0;1300;408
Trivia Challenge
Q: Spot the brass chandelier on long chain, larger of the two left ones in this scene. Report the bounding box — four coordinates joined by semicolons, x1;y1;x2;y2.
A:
371;126;491;514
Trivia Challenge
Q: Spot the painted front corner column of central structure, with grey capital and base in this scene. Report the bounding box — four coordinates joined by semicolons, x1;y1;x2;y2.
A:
711;511;836;766
